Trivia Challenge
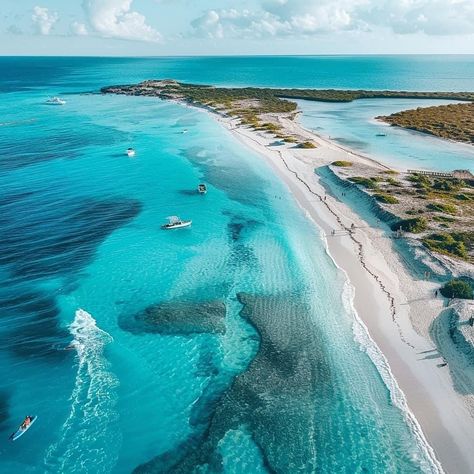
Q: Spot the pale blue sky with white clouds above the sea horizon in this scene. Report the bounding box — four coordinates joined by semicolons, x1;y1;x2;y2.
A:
0;0;474;56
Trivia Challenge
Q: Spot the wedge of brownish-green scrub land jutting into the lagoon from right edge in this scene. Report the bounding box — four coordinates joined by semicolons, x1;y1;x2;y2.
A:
377;103;474;144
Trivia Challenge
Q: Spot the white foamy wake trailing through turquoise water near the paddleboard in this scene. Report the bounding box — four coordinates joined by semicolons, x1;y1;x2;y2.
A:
44;309;122;473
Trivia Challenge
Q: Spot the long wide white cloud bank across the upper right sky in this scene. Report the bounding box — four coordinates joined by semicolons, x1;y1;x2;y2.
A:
191;0;474;38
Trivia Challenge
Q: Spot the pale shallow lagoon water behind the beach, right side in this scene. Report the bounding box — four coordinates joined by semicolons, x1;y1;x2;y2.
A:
298;99;474;171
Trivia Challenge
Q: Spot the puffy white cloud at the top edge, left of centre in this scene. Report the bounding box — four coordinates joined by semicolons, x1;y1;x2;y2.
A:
82;0;161;41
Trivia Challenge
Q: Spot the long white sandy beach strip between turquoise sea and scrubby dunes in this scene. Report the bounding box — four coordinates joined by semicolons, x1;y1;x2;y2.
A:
210;115;474;474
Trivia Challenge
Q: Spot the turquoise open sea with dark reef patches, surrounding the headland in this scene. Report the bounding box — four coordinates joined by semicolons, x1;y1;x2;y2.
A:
0;57;474;473
